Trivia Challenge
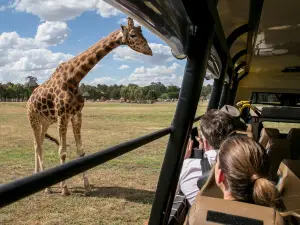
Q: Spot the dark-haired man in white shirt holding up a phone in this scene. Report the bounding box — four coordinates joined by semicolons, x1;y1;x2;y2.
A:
177;110;235;204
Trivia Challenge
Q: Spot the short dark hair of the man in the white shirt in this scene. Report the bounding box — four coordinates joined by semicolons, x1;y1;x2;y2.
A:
200;109;235;149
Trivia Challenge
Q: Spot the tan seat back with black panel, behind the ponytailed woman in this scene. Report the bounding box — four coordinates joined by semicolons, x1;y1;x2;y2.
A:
185;194;284;225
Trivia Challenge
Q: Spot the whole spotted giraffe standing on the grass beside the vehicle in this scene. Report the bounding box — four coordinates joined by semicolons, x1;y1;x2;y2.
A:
27;17;152;195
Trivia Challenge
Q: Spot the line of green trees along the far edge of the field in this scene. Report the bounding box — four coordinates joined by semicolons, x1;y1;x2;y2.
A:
0;76;212;102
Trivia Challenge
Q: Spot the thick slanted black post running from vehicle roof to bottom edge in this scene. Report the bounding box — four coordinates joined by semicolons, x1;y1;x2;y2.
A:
149;1;214;225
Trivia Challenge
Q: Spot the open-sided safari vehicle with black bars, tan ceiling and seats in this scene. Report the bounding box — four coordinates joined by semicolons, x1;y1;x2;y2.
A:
0;0;300;225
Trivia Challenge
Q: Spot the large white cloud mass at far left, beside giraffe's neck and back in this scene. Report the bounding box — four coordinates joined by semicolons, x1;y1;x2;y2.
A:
0;22;73;83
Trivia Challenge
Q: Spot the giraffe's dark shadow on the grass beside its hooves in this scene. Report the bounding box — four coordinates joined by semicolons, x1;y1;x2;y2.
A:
72;186;155;204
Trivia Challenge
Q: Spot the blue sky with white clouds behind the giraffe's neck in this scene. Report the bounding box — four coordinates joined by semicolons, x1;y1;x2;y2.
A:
0;0;211;86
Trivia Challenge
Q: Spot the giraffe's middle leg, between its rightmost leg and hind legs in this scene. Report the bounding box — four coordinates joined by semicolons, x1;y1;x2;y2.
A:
58;116;70;195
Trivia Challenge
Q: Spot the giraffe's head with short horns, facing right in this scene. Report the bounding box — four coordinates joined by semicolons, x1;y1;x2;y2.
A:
121;17;152;56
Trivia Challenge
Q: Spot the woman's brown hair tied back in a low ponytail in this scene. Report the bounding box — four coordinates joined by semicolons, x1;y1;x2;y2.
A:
218;136;281;210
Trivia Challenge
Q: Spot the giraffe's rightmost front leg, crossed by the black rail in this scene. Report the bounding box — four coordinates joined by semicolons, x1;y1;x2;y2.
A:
72;112;91;194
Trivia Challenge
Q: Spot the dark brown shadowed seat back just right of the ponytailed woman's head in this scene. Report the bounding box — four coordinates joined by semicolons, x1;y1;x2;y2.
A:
268;138;291;183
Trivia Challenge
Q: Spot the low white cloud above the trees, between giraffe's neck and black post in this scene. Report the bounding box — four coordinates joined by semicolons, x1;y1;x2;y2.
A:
118;63;182;86
